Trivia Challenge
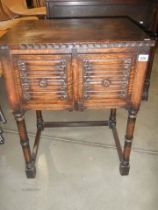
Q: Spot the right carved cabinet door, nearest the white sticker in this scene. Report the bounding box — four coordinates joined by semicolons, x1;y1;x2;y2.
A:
78;53;135;108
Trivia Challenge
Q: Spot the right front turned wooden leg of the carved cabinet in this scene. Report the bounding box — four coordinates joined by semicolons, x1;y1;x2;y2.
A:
120;110;136;175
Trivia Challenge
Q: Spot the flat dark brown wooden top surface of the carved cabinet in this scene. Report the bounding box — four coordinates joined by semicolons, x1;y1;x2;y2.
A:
0;18;153;45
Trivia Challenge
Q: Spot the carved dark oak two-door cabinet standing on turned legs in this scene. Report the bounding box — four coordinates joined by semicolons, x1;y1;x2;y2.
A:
0;18;155;178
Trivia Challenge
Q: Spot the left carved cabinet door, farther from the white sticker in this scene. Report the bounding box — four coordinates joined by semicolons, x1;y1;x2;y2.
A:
13;55;72;110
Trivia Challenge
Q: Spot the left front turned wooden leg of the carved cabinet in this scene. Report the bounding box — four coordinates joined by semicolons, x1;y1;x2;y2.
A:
14;113;36;178
